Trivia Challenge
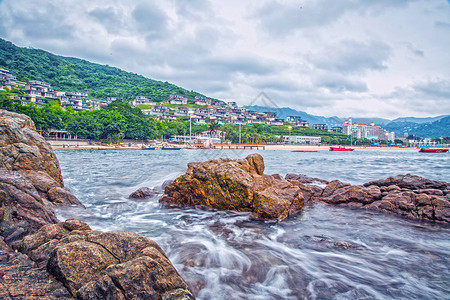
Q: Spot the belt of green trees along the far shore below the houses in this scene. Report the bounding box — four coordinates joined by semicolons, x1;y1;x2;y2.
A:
0;92;358;144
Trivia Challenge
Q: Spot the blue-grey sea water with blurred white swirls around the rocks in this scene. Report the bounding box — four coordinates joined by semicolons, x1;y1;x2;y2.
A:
55;149;450;299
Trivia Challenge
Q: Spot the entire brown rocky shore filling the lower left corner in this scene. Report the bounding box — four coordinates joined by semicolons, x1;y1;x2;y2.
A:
0;110;194;299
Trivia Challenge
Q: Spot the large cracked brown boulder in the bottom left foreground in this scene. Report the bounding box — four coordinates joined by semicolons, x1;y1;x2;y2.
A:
10;219;194;299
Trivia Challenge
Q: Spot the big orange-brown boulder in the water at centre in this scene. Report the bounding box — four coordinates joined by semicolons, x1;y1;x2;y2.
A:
160;154;304;220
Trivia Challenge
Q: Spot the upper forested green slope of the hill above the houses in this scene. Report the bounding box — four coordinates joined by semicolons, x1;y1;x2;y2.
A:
0;39;203;102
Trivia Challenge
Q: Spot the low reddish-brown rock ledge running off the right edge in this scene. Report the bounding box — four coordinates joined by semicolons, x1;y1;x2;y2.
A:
300;174;450;223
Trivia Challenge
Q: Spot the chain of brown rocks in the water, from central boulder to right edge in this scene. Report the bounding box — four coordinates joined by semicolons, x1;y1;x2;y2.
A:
160;154;450;223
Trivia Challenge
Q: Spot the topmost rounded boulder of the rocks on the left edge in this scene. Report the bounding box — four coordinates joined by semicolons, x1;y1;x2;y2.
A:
0;109;63;186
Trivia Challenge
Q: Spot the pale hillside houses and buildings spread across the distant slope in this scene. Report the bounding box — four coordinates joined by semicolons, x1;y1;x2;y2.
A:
0;69;395;144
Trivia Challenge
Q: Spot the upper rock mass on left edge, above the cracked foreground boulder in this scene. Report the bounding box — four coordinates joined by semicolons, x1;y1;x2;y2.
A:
0;110;82;244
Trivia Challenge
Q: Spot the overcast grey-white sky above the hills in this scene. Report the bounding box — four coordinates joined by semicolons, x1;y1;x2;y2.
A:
0;0;450;119
